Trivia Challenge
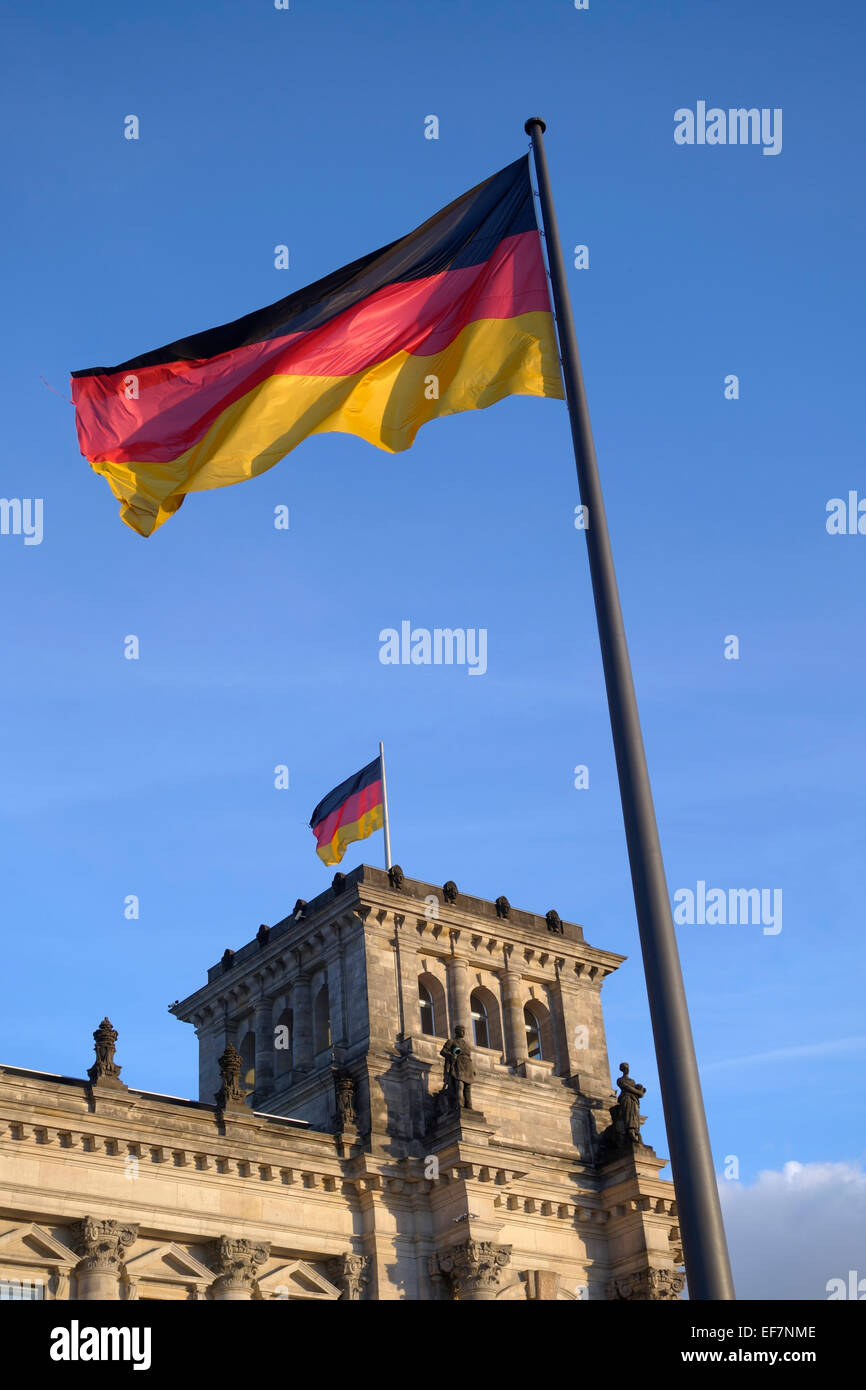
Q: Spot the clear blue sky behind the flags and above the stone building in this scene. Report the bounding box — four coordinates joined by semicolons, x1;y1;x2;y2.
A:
0;0;866;1289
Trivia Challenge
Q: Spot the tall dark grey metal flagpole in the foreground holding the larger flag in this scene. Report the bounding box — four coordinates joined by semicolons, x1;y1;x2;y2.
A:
524;115;735;1300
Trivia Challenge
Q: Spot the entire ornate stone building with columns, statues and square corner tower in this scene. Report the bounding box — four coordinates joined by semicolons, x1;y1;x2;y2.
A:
0;865;683;1301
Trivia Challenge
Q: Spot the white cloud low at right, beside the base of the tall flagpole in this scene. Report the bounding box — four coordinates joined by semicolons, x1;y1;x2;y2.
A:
719;1162;866;1300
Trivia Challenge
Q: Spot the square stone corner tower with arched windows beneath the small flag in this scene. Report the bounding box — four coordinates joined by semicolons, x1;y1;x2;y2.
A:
172;865;683;1300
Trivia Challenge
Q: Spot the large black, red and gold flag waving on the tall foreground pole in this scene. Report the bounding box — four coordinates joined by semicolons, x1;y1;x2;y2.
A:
72;156;563;535
